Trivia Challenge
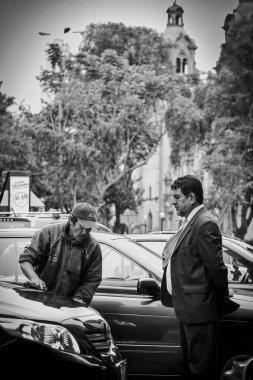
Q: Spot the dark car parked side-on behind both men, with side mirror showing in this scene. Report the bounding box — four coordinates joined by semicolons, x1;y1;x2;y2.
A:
0;228;253;380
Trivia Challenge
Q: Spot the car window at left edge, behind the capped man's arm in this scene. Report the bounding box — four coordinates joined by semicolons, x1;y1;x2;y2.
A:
0;237;31;281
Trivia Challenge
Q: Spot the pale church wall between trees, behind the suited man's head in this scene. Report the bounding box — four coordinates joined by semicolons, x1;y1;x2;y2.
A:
130;104;208;232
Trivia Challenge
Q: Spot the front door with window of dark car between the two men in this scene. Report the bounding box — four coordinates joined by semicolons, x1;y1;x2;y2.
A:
91;243;182;375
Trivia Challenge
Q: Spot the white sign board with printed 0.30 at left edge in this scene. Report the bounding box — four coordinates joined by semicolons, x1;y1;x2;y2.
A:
10;175;30;213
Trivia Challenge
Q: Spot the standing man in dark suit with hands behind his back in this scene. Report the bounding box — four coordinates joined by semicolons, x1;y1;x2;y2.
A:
161;175;239;380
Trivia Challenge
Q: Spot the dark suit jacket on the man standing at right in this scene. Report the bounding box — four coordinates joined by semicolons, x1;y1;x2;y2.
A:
161;207;239;324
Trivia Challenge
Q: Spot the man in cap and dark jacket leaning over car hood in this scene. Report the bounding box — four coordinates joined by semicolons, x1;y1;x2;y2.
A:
19;202;102;305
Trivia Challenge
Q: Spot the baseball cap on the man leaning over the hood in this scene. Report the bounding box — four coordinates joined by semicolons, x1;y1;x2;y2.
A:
71;202;98;229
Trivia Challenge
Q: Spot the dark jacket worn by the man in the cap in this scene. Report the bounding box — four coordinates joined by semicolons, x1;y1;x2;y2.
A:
19;222;102;305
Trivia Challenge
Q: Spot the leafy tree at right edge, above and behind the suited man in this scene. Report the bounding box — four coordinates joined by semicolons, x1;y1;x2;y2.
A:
163;16;253;238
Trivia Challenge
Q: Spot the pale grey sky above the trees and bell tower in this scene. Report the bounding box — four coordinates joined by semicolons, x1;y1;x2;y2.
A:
0;0;239;112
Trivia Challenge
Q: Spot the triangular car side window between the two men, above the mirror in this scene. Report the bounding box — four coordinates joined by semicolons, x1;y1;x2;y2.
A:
100;243;149;280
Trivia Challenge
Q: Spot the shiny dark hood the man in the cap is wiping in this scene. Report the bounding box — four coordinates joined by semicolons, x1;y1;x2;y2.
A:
0;282;98;323
